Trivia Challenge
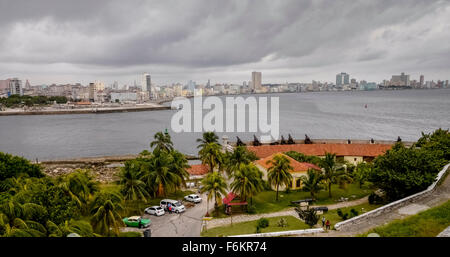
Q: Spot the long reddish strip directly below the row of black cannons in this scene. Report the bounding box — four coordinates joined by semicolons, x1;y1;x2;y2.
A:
247;144;392;158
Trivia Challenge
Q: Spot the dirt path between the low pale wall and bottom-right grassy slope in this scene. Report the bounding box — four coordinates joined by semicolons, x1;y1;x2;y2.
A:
314;166;450;237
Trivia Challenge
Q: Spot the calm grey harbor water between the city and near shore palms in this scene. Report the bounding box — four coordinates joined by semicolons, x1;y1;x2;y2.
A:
0;89;450;160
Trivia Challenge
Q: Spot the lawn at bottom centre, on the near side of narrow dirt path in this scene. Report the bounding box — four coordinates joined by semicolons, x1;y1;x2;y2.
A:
201;216;309;237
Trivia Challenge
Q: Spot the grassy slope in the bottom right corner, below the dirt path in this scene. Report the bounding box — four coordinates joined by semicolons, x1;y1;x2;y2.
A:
360;201;450;237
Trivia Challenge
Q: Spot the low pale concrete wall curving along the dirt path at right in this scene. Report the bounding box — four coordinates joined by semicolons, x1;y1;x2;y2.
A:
334;164;450;230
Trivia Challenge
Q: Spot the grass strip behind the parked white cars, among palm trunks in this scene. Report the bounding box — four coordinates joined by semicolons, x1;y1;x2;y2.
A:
100;183;194;217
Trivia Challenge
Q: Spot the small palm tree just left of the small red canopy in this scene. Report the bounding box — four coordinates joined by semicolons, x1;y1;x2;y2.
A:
201;171;228;214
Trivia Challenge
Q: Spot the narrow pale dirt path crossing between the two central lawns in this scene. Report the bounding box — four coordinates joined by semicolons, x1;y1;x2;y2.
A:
208;197;368;228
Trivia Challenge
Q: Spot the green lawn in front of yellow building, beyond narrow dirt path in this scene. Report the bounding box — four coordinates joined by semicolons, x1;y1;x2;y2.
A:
253;183;373;213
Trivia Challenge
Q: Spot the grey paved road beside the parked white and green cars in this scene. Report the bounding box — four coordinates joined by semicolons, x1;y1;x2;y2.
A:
124;192;211;237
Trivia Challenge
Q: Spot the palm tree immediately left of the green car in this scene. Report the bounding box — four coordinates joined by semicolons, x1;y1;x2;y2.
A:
91;193;123;236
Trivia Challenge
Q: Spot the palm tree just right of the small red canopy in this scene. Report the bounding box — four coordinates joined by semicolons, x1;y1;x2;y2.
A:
230;163;264;204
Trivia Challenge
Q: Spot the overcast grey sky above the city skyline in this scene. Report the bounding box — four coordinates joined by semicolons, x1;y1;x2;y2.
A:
0;0;450;85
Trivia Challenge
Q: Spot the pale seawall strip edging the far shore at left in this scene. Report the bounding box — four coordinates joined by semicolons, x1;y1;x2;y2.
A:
0;105;171;116
